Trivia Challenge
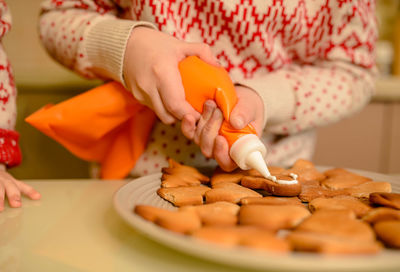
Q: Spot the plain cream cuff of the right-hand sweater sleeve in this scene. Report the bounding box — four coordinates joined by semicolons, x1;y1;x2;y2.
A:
235;71;295;127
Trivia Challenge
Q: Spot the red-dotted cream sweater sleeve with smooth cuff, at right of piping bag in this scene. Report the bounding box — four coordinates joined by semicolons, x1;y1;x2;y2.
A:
238;1;377;134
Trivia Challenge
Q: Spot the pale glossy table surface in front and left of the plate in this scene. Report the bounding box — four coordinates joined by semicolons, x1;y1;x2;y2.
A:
0;180;262;272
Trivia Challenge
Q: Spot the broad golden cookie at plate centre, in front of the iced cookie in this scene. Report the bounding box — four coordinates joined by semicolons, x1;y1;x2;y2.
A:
239;205;310;231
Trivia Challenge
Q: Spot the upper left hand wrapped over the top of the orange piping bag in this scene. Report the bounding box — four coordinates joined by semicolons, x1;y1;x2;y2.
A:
124;27;218;125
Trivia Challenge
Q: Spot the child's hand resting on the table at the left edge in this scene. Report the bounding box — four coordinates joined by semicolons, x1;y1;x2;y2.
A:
0;165;41;212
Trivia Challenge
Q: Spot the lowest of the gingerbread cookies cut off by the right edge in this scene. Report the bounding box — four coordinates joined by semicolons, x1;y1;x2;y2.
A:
374;220;400;248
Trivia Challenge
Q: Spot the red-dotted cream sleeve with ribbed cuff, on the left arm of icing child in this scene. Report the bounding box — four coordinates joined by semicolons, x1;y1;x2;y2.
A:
39;0;153;83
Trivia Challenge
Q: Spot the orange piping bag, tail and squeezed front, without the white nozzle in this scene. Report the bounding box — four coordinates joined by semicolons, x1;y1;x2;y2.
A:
25;56;269;179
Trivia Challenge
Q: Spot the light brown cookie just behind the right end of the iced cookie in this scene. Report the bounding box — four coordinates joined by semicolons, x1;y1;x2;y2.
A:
281;159;325;185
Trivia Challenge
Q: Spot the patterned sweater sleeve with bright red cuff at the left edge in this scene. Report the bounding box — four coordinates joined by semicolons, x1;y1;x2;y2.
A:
0;0;22;167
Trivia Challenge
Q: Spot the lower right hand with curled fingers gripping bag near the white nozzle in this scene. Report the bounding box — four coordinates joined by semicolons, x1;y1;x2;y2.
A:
189;86;264;171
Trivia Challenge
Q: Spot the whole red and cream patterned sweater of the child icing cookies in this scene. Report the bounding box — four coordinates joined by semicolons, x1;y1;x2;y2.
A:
40;0;377;175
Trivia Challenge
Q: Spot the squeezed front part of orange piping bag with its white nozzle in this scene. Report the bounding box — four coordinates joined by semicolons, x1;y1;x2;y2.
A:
179;56;270;177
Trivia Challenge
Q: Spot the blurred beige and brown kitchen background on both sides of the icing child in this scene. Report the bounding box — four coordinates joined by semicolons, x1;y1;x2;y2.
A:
4;0;400;179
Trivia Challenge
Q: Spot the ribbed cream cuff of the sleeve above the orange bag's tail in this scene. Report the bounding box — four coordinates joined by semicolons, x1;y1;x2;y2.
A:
85;17;155;85
